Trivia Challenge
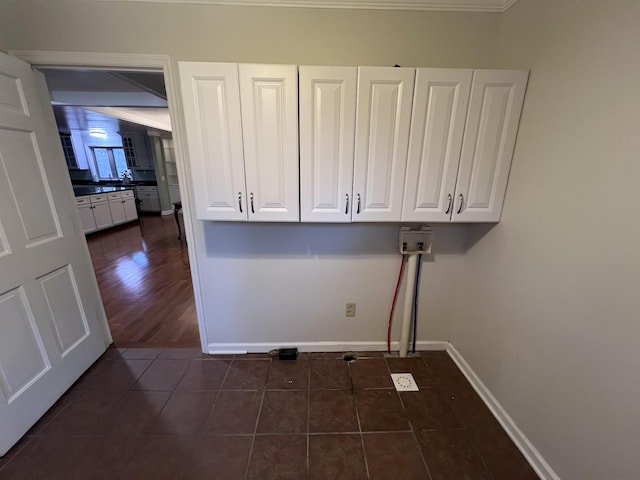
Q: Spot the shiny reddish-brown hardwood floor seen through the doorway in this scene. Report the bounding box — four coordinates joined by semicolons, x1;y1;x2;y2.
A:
87;215;200;347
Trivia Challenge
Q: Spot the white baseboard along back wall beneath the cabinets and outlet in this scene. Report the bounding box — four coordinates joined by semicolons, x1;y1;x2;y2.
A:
207;341;449;355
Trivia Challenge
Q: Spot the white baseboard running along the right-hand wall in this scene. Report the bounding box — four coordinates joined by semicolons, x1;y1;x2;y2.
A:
447;344;560;480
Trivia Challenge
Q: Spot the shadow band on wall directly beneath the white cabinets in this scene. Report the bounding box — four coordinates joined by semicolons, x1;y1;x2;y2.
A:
204;222;469;262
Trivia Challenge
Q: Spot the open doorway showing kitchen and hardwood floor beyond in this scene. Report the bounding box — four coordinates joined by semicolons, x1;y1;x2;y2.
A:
39;68;200;348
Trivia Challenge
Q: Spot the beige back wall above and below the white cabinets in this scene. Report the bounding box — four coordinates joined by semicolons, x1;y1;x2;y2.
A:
0;0;499;345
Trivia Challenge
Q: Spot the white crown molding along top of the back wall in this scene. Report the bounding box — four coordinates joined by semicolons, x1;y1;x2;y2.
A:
94;0;518;13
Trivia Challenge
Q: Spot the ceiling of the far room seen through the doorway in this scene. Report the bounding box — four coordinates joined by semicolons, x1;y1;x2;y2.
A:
43;69;171;132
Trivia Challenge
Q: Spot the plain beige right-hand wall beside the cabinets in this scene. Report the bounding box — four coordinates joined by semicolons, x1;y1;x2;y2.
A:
451;0;640;480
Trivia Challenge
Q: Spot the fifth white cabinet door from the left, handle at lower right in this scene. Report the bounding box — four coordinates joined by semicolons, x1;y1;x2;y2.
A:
402;68;473;222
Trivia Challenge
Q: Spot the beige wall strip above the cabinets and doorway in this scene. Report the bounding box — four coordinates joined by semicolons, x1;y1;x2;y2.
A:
0;0;499;67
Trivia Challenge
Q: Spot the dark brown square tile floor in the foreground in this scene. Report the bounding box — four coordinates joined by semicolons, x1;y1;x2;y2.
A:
0;349;538;480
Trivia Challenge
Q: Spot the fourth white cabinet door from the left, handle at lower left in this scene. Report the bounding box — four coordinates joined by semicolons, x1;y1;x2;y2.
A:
351;67;415;222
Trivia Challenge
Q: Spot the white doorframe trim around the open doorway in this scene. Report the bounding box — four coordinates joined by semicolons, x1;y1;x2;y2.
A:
8;50;208;352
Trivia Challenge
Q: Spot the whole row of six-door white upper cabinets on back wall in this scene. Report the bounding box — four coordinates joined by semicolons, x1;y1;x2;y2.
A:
179;62;528;223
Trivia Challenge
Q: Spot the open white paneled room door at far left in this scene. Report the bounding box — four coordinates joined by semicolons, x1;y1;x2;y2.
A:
0;54;110;455
